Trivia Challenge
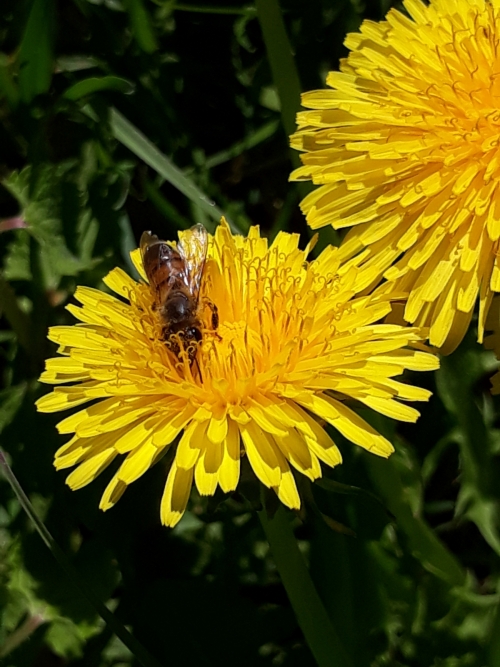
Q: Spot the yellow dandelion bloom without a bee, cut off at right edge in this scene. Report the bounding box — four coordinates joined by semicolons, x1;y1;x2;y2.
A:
292;0;500;352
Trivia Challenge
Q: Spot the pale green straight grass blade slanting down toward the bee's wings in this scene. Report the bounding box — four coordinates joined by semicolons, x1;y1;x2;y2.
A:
106;108;240;233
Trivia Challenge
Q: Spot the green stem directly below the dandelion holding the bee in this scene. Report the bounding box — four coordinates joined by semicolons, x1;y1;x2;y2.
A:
258;507;352;667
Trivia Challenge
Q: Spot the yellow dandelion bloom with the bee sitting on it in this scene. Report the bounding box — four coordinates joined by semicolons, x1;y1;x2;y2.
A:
38;221;437;526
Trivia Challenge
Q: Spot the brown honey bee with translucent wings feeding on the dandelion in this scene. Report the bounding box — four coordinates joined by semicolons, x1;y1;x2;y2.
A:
140;225;219;365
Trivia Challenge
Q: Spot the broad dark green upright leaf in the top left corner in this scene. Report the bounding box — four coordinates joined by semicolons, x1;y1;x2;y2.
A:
18;0;54;104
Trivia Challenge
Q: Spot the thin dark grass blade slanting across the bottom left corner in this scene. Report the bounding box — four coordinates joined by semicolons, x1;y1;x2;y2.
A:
0;450;165;667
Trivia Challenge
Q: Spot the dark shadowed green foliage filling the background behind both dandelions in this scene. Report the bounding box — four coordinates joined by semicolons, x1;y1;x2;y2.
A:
0;0;500;667
